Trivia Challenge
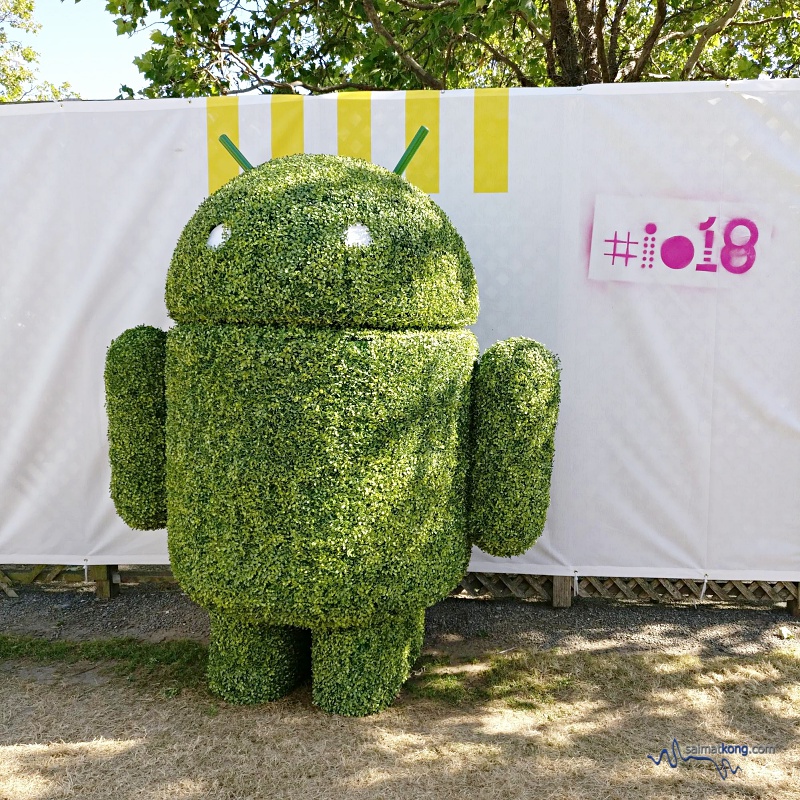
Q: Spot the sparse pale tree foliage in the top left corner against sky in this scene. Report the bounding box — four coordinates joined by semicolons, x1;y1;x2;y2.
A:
0;0;72;103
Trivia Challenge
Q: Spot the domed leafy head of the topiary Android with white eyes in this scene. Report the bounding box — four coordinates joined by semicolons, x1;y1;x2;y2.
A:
166;155;478;330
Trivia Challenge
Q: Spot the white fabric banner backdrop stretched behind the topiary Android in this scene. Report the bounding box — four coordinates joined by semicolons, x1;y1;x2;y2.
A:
0;81;800;581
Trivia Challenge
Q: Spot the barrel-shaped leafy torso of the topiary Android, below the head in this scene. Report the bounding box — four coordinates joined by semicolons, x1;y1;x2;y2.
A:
166;324;478;627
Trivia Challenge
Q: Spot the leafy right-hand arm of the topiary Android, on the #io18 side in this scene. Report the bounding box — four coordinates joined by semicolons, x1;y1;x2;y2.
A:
469;338;560;556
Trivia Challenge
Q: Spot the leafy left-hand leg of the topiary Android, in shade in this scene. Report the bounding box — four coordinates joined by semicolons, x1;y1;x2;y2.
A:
208;611;311;703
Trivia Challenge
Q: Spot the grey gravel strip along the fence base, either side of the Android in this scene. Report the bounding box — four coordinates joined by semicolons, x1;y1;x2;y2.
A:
0;586;800;657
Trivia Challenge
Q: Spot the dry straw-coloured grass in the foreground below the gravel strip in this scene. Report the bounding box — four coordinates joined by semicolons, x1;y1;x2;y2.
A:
0;646;800;800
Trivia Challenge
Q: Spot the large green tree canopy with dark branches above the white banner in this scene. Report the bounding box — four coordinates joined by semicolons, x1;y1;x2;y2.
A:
107;0;800;97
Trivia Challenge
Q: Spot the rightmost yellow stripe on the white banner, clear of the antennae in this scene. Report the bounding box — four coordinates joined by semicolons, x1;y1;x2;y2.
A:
474;89;508;192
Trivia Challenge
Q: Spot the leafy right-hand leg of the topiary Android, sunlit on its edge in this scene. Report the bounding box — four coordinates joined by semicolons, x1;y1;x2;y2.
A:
312;609;425;717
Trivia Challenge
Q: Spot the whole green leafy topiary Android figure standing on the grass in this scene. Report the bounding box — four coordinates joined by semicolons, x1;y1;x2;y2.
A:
106;155;559;715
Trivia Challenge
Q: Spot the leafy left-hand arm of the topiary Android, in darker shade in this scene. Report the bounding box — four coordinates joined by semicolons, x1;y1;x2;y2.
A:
105;325;167;530
